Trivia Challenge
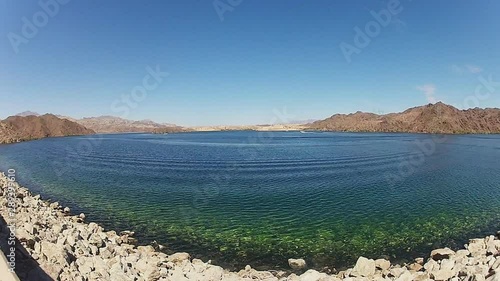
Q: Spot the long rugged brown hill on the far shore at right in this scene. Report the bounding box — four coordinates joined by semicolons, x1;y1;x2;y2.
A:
308;102;500;134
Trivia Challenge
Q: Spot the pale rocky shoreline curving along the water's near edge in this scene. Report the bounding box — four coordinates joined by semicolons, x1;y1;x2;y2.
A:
0;173;500;281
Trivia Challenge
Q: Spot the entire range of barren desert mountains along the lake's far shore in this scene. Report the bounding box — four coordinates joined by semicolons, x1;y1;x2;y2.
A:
0;102;500;143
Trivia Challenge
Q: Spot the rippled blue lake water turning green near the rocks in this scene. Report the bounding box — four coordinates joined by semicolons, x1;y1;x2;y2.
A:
0;132;500;267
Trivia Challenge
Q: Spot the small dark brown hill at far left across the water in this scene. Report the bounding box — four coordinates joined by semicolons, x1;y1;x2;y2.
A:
0;114;95;143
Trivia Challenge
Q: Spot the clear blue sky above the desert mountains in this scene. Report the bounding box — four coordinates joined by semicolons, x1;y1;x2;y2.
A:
0;0;500;125
